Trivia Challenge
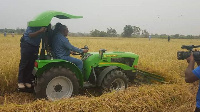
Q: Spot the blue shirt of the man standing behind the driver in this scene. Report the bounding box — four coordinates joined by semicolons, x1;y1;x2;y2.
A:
24;27;43;46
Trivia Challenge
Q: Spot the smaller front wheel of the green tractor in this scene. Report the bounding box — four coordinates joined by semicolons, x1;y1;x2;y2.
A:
102;70;128;92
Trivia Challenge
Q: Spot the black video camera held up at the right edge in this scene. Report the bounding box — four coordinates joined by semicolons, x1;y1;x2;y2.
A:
177;45;200;61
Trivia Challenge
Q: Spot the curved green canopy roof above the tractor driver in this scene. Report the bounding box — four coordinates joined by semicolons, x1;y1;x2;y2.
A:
28;11;83;27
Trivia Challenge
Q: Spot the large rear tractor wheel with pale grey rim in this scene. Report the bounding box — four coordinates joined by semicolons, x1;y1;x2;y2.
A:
34;67;79;100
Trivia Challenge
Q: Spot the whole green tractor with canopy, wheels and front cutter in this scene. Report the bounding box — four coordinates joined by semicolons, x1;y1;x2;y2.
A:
28;11;164;100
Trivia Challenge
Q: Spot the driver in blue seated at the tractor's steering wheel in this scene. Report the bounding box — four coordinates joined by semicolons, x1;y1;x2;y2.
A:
52;23;88;71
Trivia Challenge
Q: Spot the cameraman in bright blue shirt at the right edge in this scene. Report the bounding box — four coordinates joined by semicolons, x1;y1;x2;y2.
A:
185;53;200;112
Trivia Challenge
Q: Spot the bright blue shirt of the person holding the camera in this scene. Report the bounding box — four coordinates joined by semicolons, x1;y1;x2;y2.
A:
192;66;200;108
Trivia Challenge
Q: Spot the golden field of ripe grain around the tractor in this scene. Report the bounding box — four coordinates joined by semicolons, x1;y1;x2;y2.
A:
0;35;200;112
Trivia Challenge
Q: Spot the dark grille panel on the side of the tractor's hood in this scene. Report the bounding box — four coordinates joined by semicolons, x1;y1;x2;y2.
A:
111;58;135;67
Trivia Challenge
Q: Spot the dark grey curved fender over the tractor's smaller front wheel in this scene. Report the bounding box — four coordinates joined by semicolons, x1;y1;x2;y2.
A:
97;66;119;86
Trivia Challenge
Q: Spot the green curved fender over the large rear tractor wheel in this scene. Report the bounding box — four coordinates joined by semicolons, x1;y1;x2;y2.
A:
35;62;83;86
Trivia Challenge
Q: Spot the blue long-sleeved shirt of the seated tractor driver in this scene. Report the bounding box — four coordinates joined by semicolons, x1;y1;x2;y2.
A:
52;33;83;60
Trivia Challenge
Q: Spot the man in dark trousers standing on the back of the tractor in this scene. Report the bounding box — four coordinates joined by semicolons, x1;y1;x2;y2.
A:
18;27;46;92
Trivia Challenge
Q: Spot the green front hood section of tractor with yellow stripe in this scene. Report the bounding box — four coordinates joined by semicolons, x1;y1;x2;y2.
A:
82;50;139;86
